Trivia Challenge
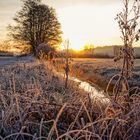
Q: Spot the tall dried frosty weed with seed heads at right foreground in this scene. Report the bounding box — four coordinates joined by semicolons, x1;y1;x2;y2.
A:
107;0;140;101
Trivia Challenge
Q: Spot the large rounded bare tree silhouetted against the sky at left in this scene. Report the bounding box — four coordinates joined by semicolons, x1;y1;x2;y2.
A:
9;0;62;53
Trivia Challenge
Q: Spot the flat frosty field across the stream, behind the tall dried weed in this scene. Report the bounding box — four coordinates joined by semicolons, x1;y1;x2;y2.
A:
54;58;140;91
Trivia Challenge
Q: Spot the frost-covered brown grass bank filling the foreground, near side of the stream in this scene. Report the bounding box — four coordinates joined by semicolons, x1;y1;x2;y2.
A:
0;57;140;140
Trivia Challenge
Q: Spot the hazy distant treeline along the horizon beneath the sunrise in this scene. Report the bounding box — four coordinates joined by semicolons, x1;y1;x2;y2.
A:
0;45;140;59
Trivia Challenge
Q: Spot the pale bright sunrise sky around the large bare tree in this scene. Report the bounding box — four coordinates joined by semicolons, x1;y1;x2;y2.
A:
0;0;131;49
